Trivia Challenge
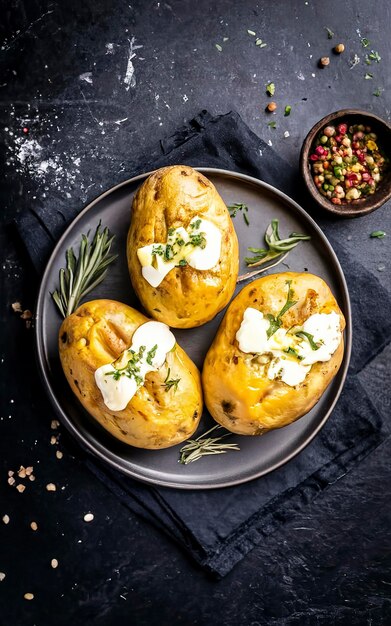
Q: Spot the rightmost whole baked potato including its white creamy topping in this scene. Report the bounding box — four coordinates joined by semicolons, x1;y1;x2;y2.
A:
202;272;345;435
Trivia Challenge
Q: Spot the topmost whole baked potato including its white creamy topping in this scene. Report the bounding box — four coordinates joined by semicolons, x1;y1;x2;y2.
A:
127;165;239;328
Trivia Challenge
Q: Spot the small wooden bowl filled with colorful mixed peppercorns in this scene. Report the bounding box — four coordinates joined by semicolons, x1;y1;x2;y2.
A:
300;109;391;217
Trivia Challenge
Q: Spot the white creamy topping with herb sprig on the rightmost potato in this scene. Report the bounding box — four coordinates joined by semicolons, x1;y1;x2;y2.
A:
236;307;341;387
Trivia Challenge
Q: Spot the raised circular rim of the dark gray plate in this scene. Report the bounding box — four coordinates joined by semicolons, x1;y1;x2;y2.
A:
34;166;352;491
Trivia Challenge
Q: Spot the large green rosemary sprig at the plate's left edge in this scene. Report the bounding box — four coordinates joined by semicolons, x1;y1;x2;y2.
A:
52;222;117;317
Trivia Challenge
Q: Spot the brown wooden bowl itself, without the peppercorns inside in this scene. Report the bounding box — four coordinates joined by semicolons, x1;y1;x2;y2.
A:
300;109;391;217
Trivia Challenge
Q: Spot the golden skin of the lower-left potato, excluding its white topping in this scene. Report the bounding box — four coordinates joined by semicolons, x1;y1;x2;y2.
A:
59;300;202;449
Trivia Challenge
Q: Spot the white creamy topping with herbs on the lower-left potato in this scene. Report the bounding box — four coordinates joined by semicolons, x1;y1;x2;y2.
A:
95;322;175;411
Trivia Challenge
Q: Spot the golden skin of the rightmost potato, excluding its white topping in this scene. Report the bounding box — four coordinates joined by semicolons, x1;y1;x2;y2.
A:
202;272;345;435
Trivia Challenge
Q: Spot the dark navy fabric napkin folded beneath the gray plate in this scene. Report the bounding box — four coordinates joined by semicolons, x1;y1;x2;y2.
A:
13;111;391;577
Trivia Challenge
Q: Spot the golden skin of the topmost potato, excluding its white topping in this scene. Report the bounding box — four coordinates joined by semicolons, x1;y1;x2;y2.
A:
127;165;239;328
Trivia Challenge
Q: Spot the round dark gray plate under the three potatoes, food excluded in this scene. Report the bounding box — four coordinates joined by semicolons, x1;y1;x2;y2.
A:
36;168;351;489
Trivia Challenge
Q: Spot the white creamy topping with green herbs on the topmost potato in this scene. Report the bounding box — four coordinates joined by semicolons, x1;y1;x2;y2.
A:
137;215;221;287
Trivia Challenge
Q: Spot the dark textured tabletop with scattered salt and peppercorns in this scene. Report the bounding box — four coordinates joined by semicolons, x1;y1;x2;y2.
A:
0;0;391;626
